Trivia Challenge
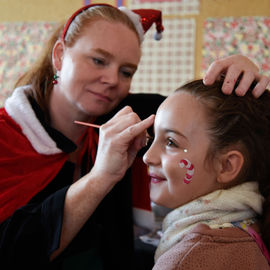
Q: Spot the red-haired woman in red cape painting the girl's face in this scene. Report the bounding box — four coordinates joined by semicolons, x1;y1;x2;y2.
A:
0;4;266;269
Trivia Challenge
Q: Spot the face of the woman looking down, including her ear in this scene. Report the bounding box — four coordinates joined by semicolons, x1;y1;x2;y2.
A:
52;20;141;116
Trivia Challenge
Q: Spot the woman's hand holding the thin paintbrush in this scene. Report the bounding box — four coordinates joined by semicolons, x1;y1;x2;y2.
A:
92;106;154;183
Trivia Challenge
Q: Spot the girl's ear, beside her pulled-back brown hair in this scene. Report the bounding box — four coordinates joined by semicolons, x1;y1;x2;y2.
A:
217;150;244;184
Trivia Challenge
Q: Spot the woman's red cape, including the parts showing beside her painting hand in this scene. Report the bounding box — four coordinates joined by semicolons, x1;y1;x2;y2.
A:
0;108;151;223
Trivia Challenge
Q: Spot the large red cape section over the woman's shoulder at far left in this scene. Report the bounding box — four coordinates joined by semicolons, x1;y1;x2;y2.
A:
0;108;67;222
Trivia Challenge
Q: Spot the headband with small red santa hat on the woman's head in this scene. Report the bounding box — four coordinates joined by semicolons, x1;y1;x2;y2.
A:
61;4;164;42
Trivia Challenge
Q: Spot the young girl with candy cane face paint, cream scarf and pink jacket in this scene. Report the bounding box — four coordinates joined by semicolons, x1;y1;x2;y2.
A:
144;77;270;270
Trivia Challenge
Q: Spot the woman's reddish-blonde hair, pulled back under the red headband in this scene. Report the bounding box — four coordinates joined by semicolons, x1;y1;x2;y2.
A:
15;5;140;118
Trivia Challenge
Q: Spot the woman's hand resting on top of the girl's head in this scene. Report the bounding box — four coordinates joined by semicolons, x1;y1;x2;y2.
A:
204;55;270;97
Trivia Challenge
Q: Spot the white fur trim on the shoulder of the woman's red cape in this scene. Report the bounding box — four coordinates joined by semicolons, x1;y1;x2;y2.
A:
5;85;62;155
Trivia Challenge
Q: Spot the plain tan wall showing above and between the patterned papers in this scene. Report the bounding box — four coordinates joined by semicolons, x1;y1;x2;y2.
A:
0;0;270;77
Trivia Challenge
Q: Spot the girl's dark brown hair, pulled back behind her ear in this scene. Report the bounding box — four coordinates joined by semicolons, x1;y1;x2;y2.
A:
176;79;270;249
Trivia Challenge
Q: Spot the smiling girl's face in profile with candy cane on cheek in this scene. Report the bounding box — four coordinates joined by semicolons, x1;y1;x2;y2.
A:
144;92;220;208
